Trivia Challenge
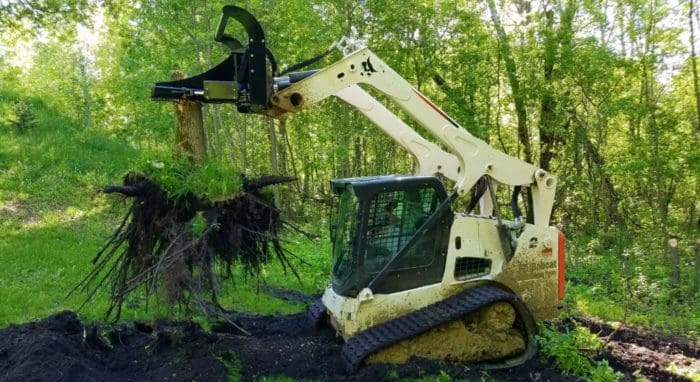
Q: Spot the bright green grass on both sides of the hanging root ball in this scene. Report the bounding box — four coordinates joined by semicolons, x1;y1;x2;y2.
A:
0;92;328;327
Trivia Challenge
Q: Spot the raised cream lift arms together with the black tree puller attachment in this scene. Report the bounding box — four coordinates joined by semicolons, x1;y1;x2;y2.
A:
152;6;557;227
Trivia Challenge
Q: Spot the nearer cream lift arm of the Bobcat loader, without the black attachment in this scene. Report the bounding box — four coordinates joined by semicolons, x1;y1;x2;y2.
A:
264;47;556;226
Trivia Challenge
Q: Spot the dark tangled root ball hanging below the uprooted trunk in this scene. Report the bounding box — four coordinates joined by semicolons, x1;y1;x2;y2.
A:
74;173;298;319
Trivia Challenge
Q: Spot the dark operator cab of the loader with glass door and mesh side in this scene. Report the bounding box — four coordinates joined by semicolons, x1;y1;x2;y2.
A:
331;175;452;297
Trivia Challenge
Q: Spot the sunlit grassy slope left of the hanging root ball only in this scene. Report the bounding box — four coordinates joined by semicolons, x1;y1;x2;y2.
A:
0;97;146;326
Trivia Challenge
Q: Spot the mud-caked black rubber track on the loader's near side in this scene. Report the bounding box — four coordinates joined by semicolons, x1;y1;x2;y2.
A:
342;285;536;370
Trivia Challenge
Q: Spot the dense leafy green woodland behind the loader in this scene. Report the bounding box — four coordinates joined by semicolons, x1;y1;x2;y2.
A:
0;0;700;333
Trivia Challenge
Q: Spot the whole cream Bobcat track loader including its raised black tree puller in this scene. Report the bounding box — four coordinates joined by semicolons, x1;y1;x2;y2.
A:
152;6;565;370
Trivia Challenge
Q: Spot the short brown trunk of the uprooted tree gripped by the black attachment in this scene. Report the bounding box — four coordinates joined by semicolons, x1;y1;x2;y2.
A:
170;71;207;163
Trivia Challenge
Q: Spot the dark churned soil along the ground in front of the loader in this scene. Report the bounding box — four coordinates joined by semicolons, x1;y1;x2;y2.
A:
0;311;698;382
